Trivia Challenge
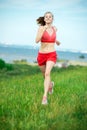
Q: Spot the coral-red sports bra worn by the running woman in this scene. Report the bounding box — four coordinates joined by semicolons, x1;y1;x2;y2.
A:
41;27;56;43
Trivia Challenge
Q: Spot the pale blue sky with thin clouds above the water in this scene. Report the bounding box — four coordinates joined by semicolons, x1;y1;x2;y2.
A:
0;0;87;51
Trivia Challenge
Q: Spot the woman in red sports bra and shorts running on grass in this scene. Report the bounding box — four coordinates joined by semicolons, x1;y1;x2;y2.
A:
36;12;60;104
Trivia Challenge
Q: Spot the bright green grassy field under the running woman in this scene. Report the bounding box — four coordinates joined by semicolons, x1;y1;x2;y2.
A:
0;64;87;130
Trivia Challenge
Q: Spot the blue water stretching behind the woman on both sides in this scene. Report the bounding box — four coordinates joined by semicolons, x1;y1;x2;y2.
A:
0;46;87;63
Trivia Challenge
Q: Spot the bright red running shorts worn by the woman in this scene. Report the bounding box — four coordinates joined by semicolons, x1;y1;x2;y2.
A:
37;51;57;66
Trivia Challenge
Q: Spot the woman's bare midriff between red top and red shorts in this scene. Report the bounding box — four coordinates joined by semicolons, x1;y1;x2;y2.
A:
39;42;55;53
